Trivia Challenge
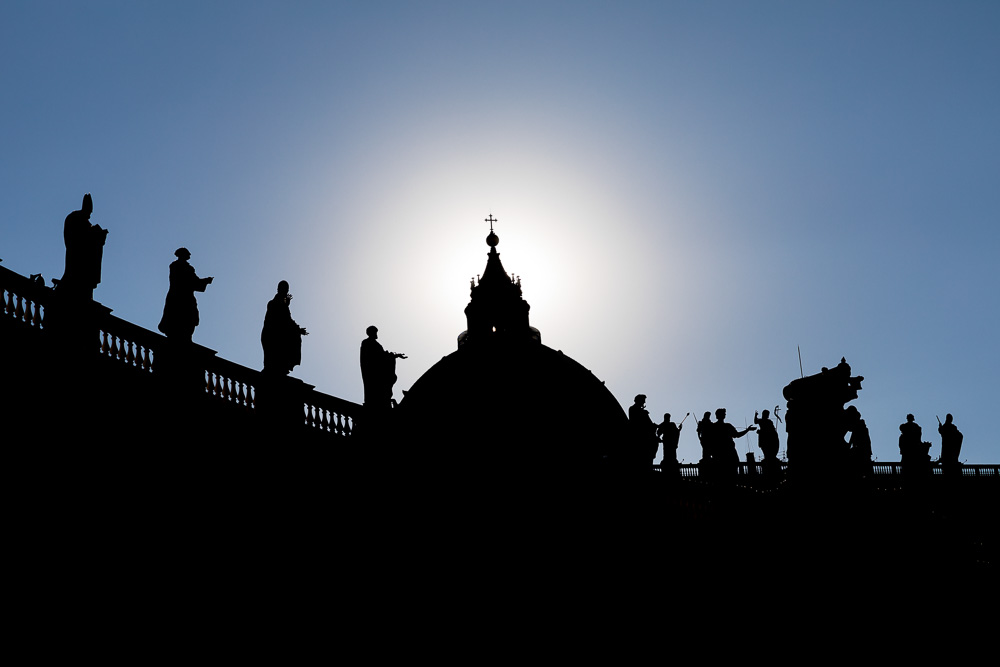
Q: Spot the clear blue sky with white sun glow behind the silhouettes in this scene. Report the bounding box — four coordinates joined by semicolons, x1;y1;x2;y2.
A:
0;0;1000;463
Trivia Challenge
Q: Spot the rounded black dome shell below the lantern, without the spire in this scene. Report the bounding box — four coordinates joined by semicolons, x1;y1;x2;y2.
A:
399;342;628;471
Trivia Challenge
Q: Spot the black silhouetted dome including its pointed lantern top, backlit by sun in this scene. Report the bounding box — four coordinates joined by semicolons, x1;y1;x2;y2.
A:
396;227;628;474
